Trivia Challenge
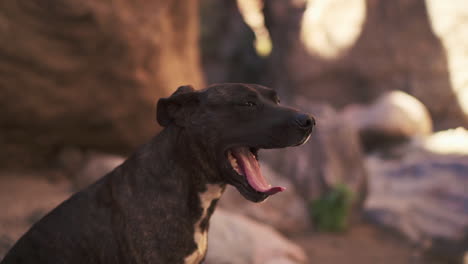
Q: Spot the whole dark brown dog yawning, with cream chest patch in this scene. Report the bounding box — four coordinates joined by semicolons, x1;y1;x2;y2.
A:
2;84;315;264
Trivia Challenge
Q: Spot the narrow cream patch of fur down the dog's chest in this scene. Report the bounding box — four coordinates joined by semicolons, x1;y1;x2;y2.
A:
185;184;224;264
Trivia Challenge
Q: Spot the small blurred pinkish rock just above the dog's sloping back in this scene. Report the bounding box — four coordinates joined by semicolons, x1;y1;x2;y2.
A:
72;152;125;191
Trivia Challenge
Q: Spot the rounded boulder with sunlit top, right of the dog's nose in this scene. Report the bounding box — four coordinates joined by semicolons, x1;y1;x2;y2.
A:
342;91;432;151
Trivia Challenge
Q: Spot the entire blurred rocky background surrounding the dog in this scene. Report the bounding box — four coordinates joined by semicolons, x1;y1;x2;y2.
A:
0;0;468;264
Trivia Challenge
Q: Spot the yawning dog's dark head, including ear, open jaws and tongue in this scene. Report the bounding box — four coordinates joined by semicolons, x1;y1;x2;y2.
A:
157;83;315;202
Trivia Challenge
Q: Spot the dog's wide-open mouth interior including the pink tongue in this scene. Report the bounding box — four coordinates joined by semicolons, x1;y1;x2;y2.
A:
227;147;285;195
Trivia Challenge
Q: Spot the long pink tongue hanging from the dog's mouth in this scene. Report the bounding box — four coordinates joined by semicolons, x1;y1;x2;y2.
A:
232;147;285;195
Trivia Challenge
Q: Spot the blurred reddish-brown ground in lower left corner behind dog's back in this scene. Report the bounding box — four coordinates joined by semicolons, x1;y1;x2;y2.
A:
0;172;71;259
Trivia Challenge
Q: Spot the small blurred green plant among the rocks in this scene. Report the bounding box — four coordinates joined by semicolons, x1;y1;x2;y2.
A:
310;184;354;232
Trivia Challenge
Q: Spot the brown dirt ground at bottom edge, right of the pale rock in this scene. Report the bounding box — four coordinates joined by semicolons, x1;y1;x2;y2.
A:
291;223;445;264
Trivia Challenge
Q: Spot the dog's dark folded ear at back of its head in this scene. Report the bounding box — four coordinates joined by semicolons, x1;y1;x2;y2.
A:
156;85;198;127
